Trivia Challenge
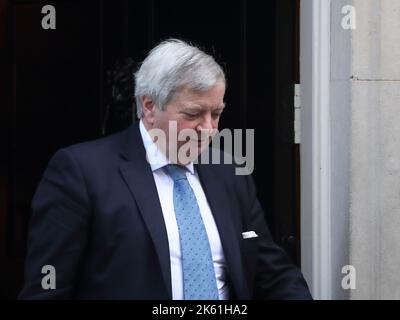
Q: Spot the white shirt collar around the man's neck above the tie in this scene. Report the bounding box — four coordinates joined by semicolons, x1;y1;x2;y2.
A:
139;119;194;174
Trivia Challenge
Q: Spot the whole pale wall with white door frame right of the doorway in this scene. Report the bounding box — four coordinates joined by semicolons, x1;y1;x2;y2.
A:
300;0;400;299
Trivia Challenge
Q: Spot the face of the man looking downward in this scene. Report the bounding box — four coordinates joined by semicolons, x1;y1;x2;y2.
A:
142;82;225;164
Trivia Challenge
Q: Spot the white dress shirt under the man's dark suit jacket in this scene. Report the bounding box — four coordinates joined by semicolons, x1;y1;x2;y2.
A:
139;120;229;300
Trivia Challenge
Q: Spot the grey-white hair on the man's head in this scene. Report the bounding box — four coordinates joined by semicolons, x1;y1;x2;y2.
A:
135;39;226;119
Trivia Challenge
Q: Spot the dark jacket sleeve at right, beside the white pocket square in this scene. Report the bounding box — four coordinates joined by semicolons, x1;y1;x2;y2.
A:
241;175;312;299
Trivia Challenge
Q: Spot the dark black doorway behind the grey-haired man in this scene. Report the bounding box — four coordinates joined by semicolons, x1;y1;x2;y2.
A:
0;0;300;298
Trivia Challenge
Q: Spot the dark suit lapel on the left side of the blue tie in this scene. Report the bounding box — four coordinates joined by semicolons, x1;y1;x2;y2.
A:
120;123;172;299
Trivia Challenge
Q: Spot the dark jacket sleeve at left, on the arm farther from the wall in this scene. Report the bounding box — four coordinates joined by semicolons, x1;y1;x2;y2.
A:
19;149;90;299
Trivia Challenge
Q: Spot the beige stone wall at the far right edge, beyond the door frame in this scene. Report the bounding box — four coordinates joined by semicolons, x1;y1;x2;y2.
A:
350;0;400;299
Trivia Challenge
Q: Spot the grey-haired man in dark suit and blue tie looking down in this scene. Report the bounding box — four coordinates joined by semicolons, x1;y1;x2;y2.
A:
20;39;311;299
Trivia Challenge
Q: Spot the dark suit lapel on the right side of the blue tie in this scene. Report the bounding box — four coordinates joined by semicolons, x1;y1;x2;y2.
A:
196;164;250;299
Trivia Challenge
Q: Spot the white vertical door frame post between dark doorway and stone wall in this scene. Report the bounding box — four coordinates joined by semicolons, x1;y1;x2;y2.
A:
300;0;332;299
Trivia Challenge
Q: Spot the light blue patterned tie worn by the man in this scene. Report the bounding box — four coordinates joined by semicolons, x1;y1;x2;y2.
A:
164;164;219;300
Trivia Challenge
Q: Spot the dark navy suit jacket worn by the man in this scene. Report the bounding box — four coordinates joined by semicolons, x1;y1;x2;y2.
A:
20;123;311;299
